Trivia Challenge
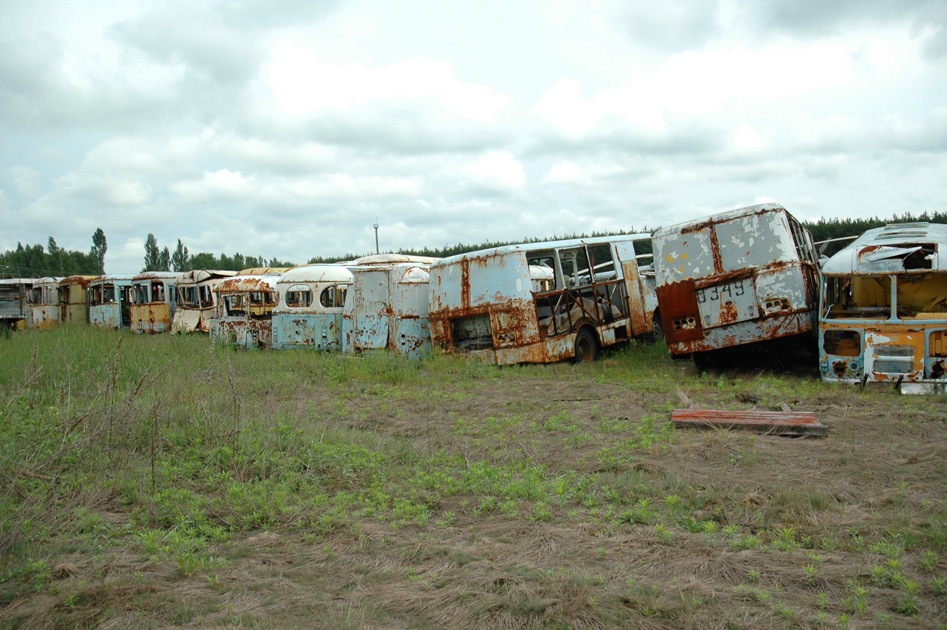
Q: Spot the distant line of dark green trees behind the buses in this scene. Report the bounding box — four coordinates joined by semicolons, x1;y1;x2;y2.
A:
0;212;947;278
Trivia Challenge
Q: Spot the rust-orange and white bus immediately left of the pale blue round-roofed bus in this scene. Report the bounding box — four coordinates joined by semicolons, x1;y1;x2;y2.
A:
210;271;279;348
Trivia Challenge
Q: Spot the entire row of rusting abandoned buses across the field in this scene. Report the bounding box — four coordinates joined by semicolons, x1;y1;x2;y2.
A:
0;204;947;392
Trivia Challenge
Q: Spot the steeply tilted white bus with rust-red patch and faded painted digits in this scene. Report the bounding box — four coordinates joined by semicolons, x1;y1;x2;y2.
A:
652;204;818;365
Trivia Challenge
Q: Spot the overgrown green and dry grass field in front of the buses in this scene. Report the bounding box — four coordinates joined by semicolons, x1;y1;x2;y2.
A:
0;327;947;627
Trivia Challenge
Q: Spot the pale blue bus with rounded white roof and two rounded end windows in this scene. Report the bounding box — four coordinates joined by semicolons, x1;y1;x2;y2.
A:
270;264;352;350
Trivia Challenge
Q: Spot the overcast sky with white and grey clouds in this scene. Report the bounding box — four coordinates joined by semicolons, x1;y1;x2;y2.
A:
0;0;947;273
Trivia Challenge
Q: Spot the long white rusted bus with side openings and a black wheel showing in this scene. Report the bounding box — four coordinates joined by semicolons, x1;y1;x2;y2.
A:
428;234;656;365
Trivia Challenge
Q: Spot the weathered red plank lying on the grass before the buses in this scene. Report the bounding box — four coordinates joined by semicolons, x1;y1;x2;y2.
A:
671;409;828;437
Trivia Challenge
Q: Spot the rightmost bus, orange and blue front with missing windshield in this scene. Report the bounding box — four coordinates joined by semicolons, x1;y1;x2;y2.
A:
819;223;947;393
